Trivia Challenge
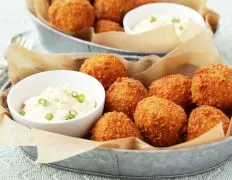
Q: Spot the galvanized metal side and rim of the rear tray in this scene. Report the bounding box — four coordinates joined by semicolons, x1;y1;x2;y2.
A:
28;10;165;56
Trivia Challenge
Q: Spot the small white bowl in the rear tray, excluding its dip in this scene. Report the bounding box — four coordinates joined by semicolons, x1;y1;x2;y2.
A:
123;3;205;35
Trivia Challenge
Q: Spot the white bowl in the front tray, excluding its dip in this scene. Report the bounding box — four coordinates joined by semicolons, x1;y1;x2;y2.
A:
7;70;105;137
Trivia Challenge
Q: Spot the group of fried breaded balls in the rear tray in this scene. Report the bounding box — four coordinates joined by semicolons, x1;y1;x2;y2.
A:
48;0;157;33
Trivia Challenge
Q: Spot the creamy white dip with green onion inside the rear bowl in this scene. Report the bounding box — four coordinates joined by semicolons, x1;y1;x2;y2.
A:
132;14;189;36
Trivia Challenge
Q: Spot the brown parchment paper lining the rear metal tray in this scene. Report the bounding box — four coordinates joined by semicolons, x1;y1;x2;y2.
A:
27;0;219;53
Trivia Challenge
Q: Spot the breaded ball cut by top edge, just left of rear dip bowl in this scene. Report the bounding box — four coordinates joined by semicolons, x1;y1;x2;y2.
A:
94;0;136;22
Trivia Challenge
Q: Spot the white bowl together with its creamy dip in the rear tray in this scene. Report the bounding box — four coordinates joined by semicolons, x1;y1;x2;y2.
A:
123;3;205;36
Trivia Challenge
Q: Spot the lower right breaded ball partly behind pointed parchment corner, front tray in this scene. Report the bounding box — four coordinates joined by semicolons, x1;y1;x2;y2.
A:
187;105;230;140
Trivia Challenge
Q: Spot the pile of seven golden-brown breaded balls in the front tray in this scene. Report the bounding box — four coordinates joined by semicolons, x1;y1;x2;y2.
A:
80;54;232;147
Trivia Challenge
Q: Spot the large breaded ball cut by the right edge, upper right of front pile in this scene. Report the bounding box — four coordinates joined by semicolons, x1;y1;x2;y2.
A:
191;64;232;109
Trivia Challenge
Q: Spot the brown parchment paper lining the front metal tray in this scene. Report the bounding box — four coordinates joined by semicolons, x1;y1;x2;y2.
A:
0;30;232;163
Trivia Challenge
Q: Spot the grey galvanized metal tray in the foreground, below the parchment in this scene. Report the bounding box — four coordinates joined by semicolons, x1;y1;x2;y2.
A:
2;73;232;179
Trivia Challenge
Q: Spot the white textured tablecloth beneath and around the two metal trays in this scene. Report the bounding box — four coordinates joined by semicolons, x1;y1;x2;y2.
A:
0;0;232;180
